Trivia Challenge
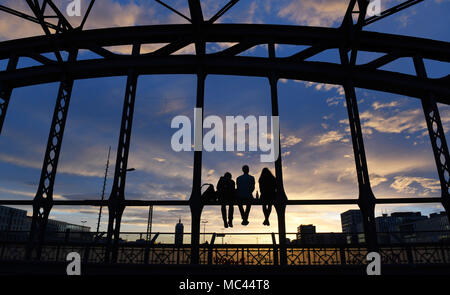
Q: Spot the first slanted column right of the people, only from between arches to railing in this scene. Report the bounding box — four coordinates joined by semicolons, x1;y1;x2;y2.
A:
339;48;377;251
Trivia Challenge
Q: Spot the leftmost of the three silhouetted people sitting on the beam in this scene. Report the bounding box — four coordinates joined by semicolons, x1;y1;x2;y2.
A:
217;172;236;228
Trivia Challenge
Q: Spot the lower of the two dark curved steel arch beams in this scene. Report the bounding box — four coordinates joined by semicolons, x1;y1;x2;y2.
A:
0;55;450;104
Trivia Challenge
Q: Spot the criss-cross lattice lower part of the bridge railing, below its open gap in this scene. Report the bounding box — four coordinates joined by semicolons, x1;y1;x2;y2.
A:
0;242;450;266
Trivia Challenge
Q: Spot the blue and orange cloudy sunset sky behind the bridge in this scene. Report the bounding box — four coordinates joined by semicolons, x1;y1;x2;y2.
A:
0;0;450;241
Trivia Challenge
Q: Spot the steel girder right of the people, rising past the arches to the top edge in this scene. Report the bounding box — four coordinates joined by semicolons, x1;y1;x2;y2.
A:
339;0;377;251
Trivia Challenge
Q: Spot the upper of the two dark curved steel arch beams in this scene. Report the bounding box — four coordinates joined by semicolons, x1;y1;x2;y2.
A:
0;24;450;62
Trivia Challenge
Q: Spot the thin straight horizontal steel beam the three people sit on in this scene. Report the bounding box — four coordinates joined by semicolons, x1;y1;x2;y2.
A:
0;198;441;207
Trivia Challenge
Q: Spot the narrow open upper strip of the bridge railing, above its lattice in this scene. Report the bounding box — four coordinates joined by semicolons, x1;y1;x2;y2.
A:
0;230;450;245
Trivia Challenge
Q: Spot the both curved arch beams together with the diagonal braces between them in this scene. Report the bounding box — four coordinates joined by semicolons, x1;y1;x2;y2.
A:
0;23;450;103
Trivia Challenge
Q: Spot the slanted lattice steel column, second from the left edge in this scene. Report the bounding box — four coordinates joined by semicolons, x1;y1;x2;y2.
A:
26;51;78;260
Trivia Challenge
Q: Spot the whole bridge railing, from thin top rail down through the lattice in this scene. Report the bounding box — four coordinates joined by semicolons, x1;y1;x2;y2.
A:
0;231;450;266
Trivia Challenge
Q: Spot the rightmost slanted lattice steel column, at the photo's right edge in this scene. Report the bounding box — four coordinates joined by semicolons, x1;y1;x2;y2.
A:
414;57;450;222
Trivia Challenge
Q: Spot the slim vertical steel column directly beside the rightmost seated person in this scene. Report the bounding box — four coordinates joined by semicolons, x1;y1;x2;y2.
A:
269;43;287;265
